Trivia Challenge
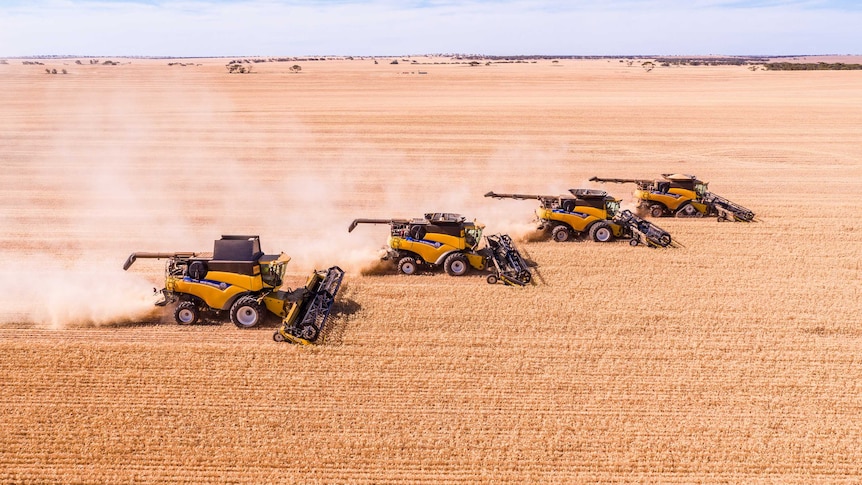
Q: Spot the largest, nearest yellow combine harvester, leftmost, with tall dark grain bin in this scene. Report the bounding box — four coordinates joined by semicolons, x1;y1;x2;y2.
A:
123;235;344;344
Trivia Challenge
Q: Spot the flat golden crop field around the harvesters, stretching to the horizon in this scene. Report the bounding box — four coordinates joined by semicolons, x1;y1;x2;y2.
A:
0;57;862;483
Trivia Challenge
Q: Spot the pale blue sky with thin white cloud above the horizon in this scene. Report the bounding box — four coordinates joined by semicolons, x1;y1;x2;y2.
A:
0;0;862;57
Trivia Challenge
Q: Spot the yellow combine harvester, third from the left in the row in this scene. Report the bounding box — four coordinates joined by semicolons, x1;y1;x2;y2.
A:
485;189;673;247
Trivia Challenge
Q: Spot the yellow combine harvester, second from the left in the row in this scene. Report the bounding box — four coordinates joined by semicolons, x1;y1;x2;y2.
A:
348;212;531;286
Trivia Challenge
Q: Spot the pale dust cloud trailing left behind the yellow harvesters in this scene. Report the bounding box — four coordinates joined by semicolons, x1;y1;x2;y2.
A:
0;81;584;329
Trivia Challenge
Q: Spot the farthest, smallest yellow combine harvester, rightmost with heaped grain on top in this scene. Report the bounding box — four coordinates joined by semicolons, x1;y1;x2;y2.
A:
590;174;754;222
